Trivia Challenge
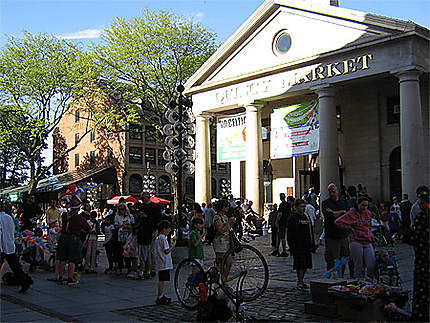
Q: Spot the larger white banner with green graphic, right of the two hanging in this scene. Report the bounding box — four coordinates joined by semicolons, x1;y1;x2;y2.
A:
270;100;320;159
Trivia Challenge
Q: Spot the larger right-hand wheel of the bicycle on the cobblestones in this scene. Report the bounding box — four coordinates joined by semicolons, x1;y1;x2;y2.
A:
221;245;269;301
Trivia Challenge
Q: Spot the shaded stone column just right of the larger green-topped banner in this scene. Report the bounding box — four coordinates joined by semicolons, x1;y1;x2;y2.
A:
316;87;339;201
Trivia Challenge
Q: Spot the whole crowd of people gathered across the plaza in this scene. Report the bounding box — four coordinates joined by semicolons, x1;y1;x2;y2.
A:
0;184;429;318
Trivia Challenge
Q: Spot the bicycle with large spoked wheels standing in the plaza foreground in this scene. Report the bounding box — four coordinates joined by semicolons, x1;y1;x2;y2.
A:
175;231;269;321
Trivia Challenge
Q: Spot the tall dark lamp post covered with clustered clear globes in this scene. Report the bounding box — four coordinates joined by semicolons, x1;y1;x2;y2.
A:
163;85;196;227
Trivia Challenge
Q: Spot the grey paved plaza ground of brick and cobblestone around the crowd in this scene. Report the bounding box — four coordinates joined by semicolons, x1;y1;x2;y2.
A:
1;235;413;322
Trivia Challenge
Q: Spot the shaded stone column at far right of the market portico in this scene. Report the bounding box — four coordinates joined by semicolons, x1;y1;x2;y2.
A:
397;71;428;200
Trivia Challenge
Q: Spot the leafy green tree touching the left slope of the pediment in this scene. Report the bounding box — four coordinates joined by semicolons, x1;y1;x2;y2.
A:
93;9;217;134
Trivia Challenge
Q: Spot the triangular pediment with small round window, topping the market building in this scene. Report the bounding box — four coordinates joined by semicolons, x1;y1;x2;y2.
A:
186;0;420;92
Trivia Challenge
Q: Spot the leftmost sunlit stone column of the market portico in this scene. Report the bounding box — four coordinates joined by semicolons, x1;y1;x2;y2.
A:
194;115;212;204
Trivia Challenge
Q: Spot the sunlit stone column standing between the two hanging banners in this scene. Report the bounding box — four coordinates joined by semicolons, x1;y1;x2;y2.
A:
245;104;264;214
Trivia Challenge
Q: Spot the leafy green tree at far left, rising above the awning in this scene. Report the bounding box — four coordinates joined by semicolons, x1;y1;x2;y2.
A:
0;32;133;194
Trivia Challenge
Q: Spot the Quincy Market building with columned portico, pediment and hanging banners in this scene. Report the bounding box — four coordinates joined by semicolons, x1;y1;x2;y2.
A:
186;0;430;212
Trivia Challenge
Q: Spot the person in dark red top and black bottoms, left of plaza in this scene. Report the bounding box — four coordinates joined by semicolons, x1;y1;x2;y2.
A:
56;198;91;285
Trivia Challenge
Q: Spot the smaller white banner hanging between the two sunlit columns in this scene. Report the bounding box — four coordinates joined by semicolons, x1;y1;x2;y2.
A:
217;113;246;163
